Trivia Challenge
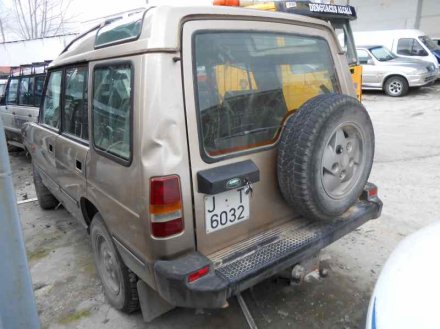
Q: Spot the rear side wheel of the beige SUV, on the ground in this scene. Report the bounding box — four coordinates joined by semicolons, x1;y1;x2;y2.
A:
90;213;139;313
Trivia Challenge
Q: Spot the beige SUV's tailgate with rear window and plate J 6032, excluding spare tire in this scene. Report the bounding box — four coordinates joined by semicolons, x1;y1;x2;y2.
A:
182;20;347;254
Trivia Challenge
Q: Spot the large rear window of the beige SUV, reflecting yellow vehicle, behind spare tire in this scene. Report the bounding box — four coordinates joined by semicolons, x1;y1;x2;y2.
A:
193;31;339;158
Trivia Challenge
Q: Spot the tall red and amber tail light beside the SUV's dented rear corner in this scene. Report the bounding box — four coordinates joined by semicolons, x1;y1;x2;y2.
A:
150;175;184;238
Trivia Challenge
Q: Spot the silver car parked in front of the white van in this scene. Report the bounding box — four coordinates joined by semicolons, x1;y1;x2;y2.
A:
356;46;438;97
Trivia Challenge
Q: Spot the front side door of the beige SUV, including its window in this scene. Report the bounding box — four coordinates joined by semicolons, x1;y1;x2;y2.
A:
32;69;63;192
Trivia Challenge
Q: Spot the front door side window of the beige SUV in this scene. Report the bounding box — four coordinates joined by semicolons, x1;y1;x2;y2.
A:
41;71;62;128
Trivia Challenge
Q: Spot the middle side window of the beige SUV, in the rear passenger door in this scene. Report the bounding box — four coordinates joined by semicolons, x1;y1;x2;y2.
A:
63;67;89;140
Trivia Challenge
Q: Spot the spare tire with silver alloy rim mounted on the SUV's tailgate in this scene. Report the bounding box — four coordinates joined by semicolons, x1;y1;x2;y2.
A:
277;94;374;220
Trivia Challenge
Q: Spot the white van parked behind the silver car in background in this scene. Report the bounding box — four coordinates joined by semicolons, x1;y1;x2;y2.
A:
353;29;440;68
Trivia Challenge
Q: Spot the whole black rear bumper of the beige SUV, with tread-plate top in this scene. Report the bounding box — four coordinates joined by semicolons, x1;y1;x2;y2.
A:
154;184;382;308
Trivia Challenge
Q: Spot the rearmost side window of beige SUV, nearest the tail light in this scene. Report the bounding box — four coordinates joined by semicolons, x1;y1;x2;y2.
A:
92;64;133;161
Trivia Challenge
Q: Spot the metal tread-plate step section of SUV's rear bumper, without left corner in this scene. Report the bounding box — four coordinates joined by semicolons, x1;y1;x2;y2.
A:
209;201;381;290
